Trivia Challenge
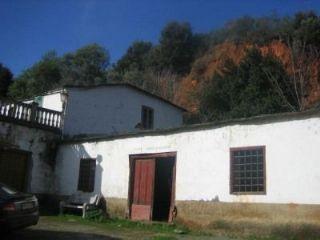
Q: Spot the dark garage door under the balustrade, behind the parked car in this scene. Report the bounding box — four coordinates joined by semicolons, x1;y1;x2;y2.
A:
0;150;29;191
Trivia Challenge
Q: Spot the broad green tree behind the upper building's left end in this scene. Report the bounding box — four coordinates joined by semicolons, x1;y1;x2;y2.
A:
9;44;109;99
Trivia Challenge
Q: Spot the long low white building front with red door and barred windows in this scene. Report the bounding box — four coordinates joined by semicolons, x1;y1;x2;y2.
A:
55;110;320;220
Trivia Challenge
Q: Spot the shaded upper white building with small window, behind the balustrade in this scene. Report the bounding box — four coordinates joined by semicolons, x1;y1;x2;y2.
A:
28;84;186;136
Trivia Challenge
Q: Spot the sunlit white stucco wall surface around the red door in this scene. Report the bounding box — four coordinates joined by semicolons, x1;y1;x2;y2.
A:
55;115;320;204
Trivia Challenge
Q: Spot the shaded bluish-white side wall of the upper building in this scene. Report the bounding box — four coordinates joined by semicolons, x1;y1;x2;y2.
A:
63;86;183;135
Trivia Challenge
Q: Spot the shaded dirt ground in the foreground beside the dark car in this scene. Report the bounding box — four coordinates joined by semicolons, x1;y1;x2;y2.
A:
0;217;231;240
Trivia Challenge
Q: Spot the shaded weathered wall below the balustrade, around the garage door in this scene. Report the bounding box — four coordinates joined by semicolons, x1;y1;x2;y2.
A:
0;121;59;193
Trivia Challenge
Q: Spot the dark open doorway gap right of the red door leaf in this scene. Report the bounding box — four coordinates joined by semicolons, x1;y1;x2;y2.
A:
152;157;175;221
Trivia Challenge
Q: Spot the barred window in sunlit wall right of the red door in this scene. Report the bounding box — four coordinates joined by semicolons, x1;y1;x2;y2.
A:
230;146;266;194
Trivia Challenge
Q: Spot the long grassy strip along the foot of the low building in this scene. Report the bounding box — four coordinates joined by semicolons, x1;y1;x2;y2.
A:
48;210;320;240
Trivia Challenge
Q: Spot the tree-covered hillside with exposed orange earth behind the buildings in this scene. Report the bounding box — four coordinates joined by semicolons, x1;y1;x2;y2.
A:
0;12;320;122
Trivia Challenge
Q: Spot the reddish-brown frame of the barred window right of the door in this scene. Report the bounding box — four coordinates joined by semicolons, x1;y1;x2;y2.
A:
229;145;267;195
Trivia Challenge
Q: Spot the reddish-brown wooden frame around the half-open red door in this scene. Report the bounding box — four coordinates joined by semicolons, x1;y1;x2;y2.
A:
127;152;177;222
